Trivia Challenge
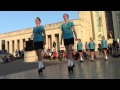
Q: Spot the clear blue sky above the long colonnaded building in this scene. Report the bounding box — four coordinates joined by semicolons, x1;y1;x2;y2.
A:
0;11;78;34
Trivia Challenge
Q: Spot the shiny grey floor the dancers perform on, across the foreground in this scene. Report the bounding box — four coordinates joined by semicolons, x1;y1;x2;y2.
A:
0;54;120;79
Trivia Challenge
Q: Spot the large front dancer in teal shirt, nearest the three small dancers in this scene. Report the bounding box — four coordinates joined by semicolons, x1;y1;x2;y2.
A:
61;14;77;72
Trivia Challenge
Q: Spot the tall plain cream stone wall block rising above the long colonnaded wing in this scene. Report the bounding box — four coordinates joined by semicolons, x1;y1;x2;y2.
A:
77;11;95;47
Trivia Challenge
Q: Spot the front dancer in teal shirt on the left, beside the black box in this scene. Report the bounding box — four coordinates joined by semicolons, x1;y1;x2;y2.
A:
32;17;46;74
